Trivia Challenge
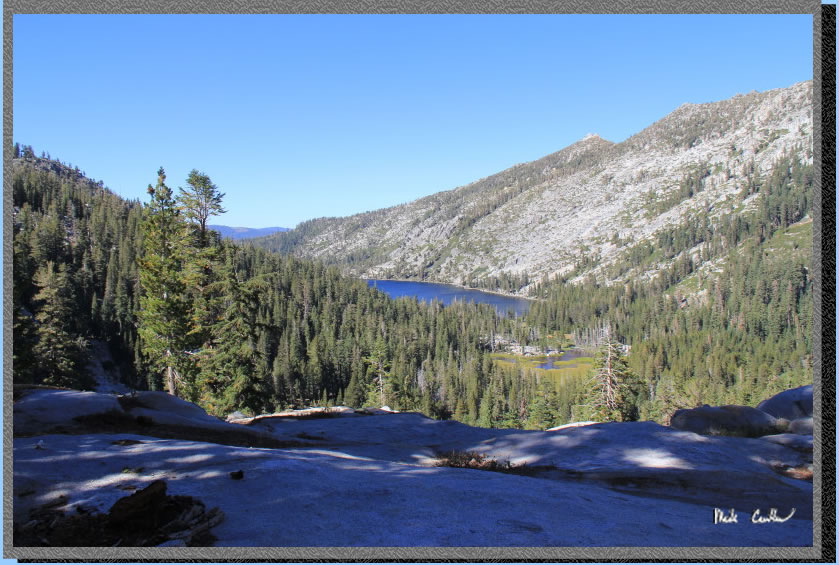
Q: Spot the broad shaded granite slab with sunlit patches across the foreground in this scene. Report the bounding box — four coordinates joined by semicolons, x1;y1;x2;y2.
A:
12;388;813;547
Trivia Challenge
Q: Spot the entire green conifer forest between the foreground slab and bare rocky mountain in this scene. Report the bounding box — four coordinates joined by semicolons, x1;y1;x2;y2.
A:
12;133;813;429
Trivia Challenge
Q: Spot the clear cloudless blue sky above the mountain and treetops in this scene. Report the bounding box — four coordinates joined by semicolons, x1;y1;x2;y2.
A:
13;15;813;227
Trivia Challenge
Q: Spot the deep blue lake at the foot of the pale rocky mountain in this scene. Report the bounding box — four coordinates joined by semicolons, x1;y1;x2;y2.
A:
367;279;531;316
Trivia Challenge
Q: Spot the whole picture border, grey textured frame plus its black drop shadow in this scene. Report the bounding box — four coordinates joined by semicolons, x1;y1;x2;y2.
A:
3;0;836;562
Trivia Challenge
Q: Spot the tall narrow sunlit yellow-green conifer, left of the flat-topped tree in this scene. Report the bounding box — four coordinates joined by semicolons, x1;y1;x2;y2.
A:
137;168;190;395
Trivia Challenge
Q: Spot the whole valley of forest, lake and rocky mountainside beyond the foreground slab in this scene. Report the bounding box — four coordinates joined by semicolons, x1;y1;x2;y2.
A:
13;82;814;429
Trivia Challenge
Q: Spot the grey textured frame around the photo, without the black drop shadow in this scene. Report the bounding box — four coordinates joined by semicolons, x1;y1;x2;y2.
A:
3;0;830;562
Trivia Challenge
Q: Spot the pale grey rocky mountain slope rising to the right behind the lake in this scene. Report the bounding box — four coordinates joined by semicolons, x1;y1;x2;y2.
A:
254;81;813;292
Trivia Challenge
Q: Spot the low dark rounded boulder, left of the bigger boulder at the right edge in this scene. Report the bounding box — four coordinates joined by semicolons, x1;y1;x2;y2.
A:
670;404;779;437
